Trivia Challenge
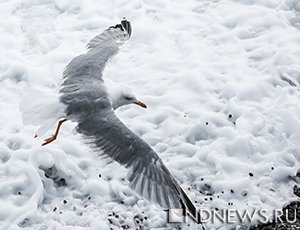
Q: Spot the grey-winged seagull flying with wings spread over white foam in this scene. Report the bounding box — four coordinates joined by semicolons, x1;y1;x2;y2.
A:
54;19;199;223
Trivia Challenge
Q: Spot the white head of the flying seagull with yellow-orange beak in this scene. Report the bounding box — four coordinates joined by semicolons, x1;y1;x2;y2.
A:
110;85;147;109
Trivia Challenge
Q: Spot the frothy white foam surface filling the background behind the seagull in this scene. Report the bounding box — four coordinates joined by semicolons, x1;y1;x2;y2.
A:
0;0;300;230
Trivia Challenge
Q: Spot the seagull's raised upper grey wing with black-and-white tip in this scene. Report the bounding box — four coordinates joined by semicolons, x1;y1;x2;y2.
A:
60;20;131;115
